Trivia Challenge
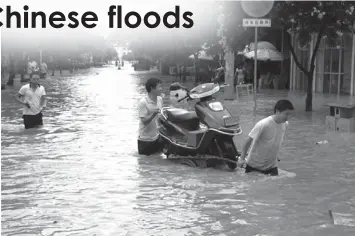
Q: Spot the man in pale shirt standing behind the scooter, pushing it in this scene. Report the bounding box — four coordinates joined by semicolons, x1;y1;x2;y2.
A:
138;78;163;155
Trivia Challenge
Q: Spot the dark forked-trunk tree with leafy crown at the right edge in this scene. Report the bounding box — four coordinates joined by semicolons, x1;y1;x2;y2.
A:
270;1;355;111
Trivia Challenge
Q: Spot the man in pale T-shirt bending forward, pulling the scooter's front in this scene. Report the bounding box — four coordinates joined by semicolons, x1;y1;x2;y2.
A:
238;100;294;175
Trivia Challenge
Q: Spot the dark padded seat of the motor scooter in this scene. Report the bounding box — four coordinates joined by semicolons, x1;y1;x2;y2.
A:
166;108;200;130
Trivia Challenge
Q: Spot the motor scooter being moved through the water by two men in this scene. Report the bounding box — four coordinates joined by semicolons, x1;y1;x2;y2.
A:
158;83;242;170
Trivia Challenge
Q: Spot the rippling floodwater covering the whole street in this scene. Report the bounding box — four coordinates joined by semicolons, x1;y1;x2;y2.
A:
1;66;355;236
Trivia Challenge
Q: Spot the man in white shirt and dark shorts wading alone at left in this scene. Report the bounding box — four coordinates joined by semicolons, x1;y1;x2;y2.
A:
16;74;47;129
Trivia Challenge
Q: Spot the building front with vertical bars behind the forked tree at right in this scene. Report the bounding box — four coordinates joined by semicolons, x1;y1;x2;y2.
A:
290;33;355;95
